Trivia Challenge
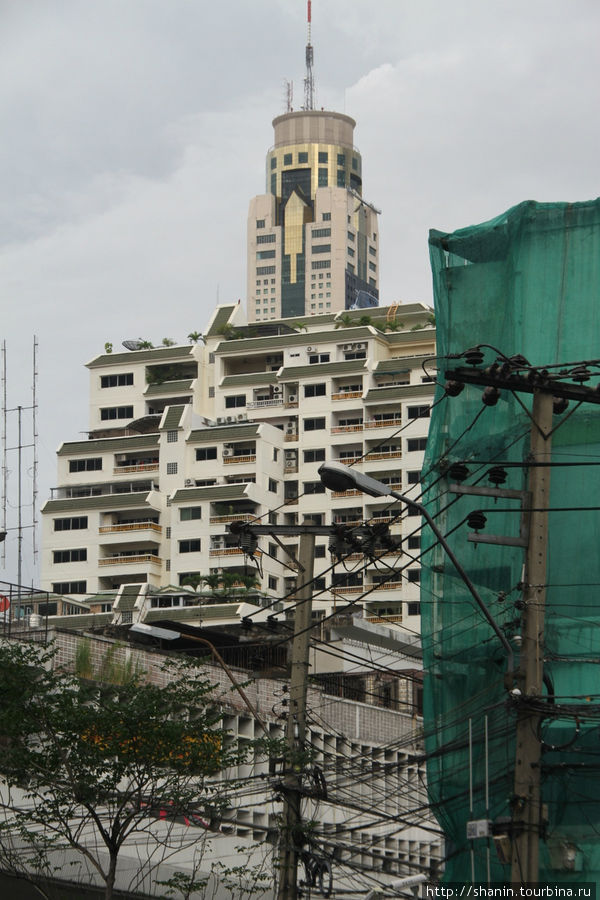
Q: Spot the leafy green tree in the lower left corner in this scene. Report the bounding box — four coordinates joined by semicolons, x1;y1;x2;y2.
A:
0;642;268;900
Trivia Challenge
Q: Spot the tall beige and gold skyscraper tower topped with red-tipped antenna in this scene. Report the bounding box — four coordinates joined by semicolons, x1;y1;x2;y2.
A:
247;0;379;321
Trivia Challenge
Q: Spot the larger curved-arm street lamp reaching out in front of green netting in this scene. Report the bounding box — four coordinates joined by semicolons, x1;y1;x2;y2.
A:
318;462;514;672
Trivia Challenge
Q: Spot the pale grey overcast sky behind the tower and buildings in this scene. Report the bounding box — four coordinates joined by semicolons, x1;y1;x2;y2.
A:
0;0;600;583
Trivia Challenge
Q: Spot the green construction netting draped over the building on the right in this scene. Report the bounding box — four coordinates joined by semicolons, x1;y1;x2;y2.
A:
421;200;600;883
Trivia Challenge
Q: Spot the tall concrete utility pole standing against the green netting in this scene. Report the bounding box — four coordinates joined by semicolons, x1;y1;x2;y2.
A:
511;391;553;885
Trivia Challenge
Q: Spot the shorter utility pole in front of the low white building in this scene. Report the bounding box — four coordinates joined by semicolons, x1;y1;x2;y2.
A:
277;533;315;900
